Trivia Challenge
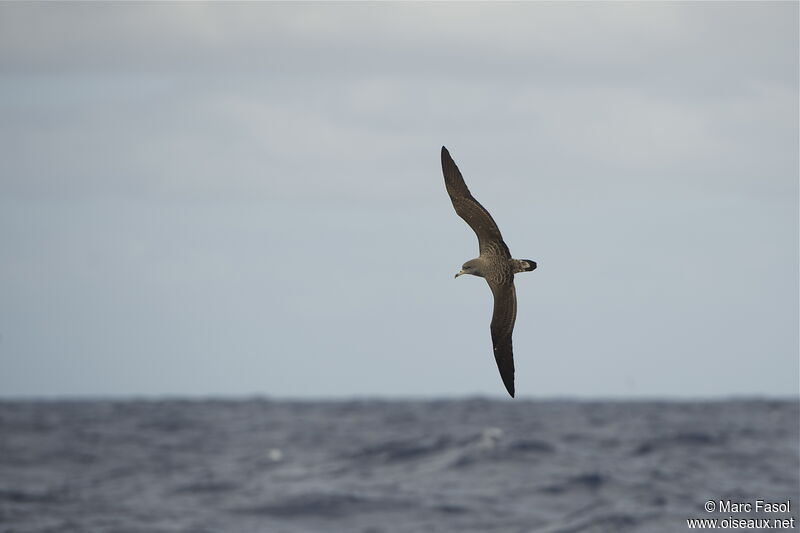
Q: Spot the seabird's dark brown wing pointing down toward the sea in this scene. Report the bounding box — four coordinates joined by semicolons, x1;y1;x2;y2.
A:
486;280;517;398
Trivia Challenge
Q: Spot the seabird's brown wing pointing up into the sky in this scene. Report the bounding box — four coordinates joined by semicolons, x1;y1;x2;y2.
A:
442;146;511;258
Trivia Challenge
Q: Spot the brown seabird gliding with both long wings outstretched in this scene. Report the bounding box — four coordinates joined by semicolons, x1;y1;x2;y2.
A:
442;146;536;398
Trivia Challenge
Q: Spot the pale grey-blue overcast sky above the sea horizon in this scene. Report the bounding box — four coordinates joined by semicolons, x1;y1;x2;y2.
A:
0;2;800;397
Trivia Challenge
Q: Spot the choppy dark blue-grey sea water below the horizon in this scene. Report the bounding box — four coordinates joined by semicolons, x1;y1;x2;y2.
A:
0;399;800;533
